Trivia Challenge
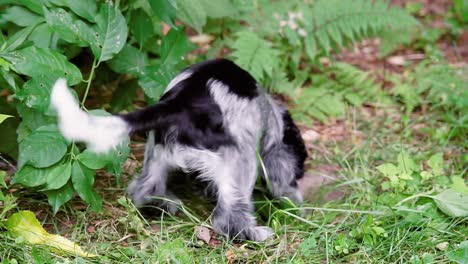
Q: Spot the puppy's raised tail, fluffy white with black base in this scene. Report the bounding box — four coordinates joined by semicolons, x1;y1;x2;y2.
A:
51;79;163;153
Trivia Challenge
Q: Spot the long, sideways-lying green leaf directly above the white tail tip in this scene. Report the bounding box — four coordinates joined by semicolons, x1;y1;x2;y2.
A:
10;47;82;85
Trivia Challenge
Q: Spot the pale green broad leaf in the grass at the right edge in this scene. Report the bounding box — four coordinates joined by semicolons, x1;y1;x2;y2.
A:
431;189;468;217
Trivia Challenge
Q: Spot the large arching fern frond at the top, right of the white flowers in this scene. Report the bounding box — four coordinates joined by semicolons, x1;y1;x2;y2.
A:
304;0;418;59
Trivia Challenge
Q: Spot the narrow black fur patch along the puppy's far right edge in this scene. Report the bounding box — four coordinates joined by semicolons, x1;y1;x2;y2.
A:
283;111;307;182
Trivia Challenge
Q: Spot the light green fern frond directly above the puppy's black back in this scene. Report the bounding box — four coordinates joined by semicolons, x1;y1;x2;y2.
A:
232;31;279;81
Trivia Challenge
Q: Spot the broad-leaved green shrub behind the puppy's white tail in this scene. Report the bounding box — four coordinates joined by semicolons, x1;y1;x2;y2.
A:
0;0;235;212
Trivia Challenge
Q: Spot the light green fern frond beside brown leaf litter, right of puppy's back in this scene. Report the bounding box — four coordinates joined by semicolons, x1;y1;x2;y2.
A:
292;63;381;124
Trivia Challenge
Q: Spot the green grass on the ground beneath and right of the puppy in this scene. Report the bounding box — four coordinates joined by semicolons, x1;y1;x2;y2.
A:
0;104;468;263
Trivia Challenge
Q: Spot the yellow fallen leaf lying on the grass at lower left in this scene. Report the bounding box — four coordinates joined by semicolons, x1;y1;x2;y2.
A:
6;211;96;257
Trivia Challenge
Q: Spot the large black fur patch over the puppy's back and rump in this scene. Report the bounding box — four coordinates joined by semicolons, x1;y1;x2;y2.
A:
122;59;258;150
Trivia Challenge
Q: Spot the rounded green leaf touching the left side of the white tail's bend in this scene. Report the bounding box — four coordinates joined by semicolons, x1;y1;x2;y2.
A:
18;125;67;168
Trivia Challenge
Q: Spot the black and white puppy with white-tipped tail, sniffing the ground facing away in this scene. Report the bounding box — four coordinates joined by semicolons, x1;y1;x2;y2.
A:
51;59;307;241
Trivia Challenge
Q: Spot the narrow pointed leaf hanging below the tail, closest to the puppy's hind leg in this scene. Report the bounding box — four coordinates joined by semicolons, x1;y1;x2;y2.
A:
72;161;102;212
